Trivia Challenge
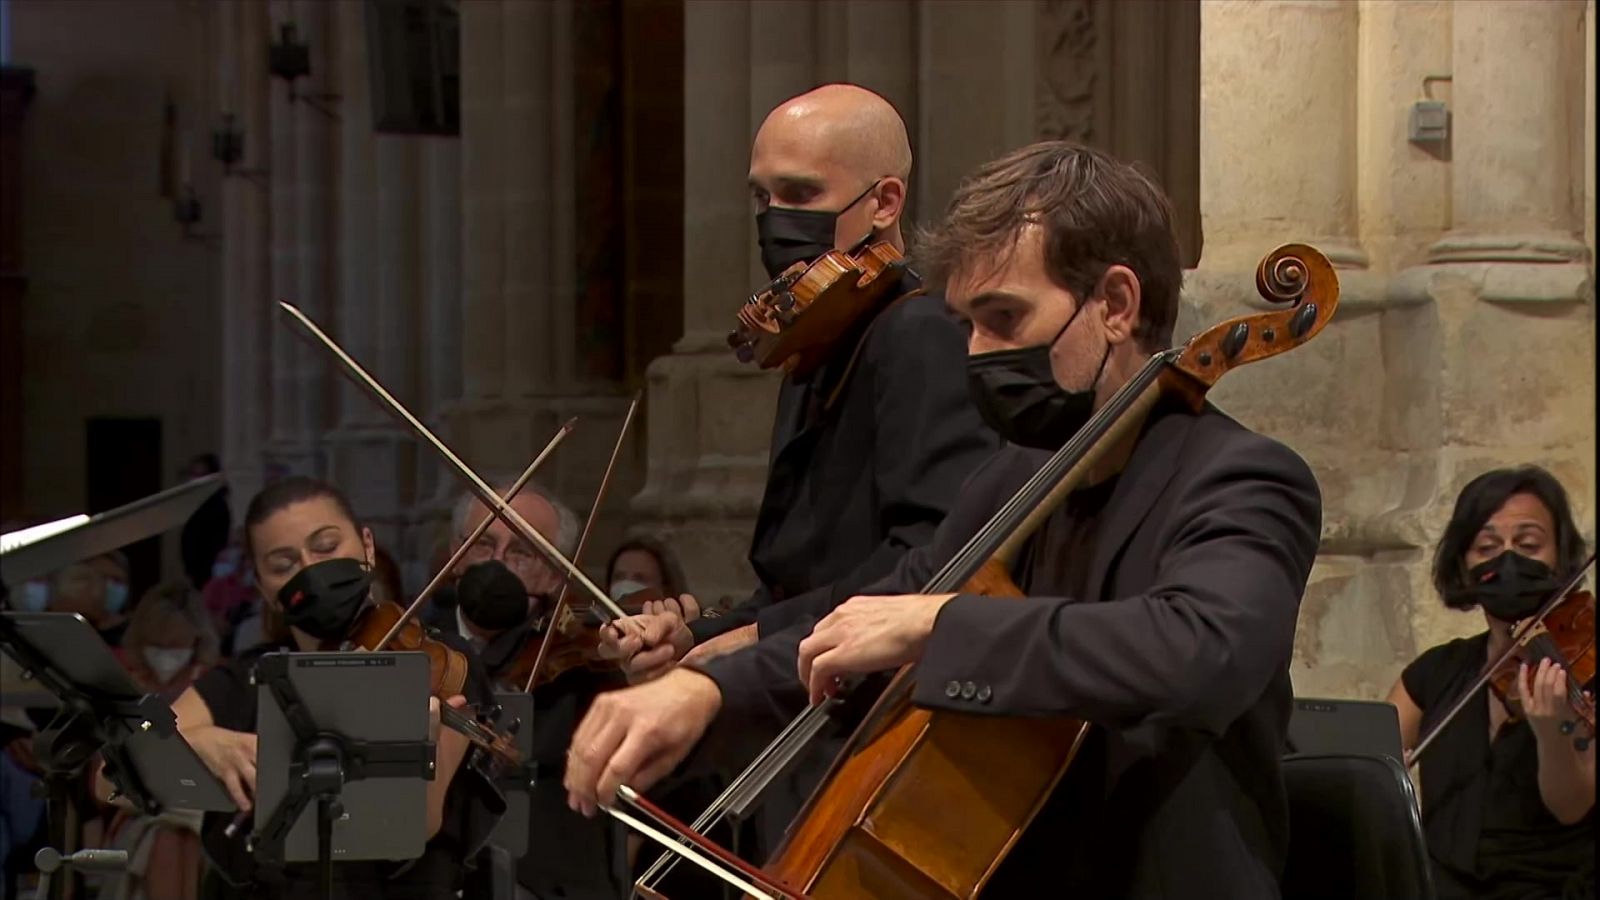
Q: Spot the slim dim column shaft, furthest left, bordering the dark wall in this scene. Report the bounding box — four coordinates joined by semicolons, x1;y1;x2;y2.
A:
216;2;272;517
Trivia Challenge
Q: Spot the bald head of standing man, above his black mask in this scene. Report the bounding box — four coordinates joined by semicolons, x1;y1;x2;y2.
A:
750;85;912;254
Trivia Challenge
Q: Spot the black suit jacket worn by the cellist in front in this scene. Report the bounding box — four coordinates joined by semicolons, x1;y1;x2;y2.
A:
698;408;1322;900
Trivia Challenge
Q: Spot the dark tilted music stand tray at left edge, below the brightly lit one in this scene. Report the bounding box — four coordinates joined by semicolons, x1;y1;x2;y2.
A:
0;612;235;814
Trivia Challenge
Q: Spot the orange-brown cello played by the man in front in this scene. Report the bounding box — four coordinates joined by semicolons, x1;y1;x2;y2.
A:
620;243;1339;900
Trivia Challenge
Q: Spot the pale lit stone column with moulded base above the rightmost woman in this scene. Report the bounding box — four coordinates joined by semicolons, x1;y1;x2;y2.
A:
1392;0;1595;649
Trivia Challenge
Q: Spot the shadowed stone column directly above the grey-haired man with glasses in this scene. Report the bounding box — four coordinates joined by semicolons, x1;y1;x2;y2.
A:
442;0;637;573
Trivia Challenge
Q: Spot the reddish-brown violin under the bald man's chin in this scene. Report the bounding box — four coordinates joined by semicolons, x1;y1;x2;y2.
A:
728;242;906;375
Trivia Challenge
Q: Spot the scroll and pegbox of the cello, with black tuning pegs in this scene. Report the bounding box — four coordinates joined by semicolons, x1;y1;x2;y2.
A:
1173;243;1339;389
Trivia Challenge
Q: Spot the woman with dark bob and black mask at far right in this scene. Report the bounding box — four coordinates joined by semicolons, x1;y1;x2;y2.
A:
1389;466;1595;900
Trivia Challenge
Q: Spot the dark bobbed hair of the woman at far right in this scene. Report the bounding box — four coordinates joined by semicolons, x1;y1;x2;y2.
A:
1434;466;1589;610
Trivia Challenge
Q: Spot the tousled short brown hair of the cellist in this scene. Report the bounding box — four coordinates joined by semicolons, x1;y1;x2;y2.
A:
915;141;1184;351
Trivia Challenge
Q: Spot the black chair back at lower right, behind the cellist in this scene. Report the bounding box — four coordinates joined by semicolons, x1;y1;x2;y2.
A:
1283;754;1434;900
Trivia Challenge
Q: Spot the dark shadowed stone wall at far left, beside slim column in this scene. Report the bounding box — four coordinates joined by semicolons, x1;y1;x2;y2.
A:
5;0;224;572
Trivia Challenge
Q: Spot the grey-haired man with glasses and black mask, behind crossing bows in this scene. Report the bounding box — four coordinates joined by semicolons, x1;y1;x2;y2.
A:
430;477;627;900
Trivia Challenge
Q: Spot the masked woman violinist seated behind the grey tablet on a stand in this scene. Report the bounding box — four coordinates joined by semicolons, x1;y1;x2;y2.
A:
148;477;504;900
